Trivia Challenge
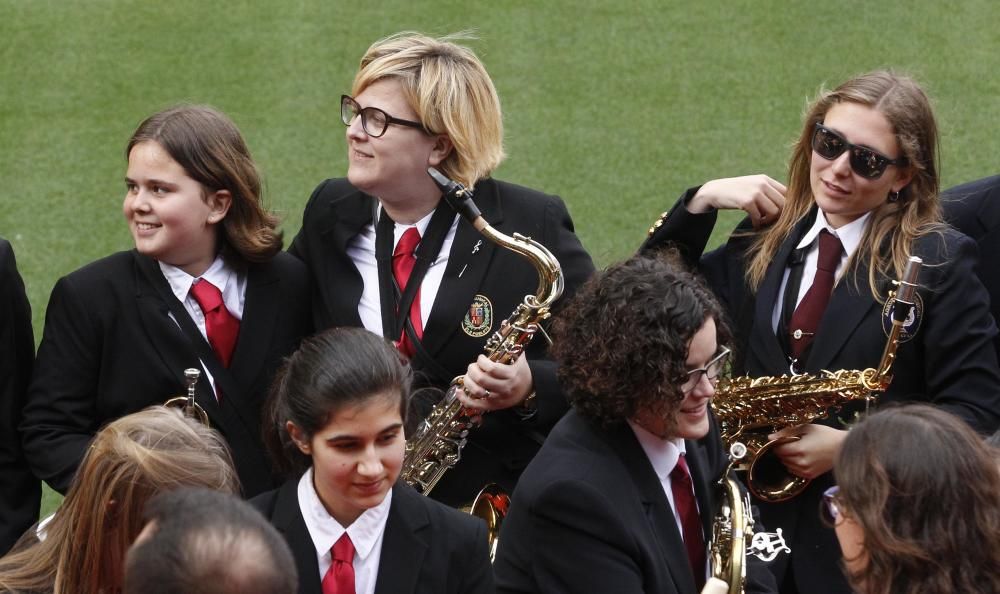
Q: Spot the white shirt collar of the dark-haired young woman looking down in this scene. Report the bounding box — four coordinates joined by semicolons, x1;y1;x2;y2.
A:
298;467;392;559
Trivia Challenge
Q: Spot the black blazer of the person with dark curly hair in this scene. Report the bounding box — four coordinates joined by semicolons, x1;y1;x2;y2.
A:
494;411;777;594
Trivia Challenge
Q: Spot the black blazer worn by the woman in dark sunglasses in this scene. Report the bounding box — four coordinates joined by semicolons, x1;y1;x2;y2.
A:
642;188;1000;593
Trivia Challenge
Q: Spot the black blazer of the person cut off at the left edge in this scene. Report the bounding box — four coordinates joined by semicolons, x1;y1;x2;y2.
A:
0;238;42;556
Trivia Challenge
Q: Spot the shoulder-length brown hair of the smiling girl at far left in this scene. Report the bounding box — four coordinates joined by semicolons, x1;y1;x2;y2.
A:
125;105;282;263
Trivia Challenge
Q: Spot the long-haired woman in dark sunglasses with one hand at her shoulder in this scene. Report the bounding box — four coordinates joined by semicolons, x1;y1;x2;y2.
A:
643;72;1000;593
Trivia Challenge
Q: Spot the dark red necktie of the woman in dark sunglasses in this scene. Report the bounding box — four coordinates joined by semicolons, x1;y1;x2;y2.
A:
788;229;844;359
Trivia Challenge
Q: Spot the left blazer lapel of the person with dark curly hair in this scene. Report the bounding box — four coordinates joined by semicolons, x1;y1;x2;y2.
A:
608;423;701;592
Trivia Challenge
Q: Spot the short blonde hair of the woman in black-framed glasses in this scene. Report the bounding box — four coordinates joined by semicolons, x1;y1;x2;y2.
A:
351;32;506;188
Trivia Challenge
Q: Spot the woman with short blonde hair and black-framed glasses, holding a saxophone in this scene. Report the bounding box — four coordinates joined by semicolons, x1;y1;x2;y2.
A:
290;33;593;504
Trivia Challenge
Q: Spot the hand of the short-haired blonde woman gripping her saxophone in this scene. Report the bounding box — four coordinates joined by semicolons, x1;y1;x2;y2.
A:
458;353;533;412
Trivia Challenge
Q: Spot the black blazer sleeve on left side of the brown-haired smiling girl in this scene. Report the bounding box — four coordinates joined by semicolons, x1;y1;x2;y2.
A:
21;277;104;493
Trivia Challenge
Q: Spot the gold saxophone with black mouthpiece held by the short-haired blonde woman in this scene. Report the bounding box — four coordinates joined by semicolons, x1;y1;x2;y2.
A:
400;167;564;557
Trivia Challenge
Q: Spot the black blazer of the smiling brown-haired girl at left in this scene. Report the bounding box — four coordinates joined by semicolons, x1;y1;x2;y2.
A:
21;250;311;496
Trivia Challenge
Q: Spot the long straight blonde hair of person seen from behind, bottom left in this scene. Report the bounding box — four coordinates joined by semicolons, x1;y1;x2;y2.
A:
0;406;239;594
